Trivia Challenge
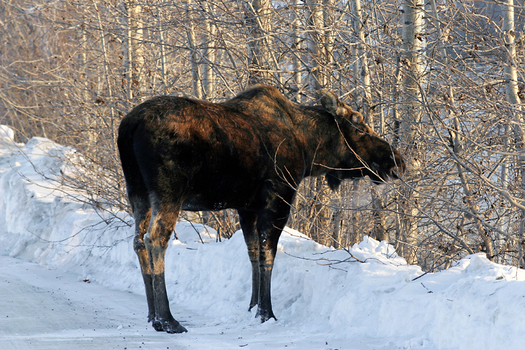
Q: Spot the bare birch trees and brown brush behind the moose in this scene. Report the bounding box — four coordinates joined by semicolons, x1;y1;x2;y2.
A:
0;0;525;271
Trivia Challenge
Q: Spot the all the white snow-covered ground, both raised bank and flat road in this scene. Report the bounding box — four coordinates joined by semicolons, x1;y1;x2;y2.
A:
0;127;525;350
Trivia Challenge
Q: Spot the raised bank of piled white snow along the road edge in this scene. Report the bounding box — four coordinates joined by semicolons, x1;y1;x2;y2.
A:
0;126;525;350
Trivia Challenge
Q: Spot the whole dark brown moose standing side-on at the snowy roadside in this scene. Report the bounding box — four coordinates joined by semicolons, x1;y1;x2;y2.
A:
118;85;405;333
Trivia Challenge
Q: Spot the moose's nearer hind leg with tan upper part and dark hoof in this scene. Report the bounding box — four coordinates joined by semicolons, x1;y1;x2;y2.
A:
144;200;187;333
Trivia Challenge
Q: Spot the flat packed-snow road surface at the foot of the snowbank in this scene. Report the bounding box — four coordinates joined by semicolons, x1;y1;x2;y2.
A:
0;255;372;350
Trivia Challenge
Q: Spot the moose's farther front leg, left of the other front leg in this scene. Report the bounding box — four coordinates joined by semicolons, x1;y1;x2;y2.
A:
239;211;260;310
